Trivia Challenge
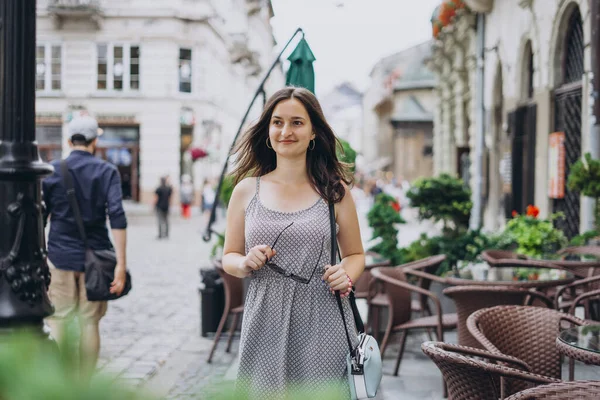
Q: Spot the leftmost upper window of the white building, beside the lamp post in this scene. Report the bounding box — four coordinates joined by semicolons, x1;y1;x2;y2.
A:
35;44;62;92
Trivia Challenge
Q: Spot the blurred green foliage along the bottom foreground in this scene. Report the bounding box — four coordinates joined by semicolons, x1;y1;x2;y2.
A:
0;321;347;400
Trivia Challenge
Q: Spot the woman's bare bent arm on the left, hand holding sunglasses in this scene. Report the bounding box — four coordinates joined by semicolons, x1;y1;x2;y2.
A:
222;179;275;278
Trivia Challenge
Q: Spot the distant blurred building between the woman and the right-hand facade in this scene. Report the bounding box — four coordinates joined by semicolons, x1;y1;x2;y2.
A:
363;42;436;181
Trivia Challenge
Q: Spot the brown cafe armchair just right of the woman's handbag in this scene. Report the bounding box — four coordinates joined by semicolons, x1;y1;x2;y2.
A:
369;266;456;376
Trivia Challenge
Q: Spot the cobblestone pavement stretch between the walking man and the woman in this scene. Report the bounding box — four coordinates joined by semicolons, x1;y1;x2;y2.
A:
98;214;225;396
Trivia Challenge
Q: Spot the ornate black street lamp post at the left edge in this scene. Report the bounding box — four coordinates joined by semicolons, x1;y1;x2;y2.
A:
0;0;53;334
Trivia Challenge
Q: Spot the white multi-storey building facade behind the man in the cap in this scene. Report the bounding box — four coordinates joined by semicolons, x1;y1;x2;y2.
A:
36;0;284;202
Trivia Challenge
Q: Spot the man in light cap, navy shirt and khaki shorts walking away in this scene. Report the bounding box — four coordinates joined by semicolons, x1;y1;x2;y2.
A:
42;116;127;376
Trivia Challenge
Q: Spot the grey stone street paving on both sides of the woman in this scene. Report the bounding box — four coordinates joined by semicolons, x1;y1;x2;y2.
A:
99;208;441;400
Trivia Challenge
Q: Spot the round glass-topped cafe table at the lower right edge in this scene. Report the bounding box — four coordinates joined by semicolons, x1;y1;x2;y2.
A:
556;325;600;365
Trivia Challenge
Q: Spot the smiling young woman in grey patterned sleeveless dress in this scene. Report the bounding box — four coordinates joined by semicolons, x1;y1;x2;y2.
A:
223;87;365;398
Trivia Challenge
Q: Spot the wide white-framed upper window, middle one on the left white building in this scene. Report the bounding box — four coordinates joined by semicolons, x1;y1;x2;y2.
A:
96;43;140;92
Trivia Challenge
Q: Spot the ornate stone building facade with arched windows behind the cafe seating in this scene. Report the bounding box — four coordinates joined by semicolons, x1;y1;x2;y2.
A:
431;0;591;236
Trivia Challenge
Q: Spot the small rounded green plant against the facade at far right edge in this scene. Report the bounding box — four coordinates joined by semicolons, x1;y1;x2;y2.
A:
567;153;600;241
